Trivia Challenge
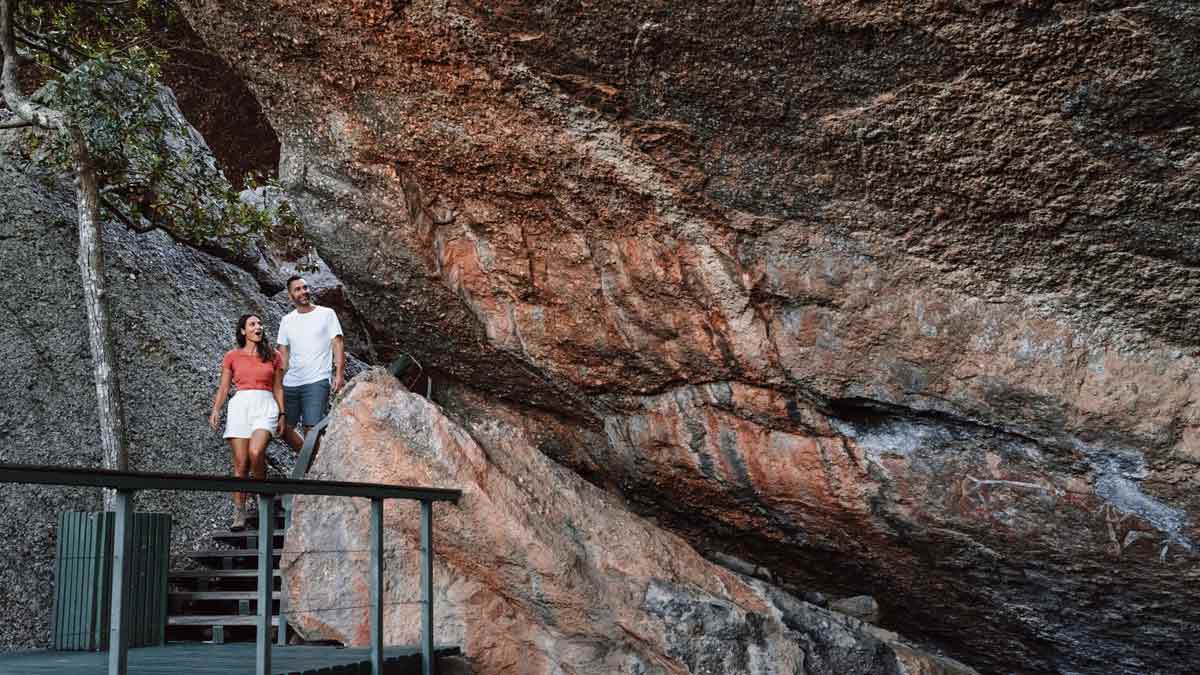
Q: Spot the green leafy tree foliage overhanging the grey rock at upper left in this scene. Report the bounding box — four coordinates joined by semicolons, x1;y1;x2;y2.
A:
10;0;311;257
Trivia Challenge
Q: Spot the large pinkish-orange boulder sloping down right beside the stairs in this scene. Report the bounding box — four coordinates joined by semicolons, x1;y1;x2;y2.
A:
282;369;974;675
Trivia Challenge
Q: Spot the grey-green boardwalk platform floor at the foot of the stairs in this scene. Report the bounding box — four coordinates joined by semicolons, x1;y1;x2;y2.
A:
0;643;458;675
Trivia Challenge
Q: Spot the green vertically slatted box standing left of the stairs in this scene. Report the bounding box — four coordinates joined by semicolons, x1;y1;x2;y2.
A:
50;512;170;651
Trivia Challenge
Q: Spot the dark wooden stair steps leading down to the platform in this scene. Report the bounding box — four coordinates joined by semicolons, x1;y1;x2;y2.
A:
167;500;286;644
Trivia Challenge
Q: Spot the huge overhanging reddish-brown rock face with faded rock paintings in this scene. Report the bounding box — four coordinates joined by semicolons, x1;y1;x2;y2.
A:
177;0;1200;673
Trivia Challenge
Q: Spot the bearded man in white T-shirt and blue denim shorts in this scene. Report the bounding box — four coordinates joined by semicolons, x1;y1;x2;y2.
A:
276;276;346;450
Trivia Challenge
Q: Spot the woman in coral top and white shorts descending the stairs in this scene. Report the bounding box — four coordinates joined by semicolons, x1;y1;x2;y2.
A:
209;313;284;530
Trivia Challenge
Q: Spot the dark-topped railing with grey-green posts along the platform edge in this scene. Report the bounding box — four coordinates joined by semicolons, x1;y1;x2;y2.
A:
0;464;462;675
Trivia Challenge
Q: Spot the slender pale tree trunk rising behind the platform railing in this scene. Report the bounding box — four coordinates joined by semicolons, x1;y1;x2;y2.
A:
64;123;130;510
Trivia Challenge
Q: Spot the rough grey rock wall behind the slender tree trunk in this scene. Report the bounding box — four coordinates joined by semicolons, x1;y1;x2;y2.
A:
0;137;324;650
